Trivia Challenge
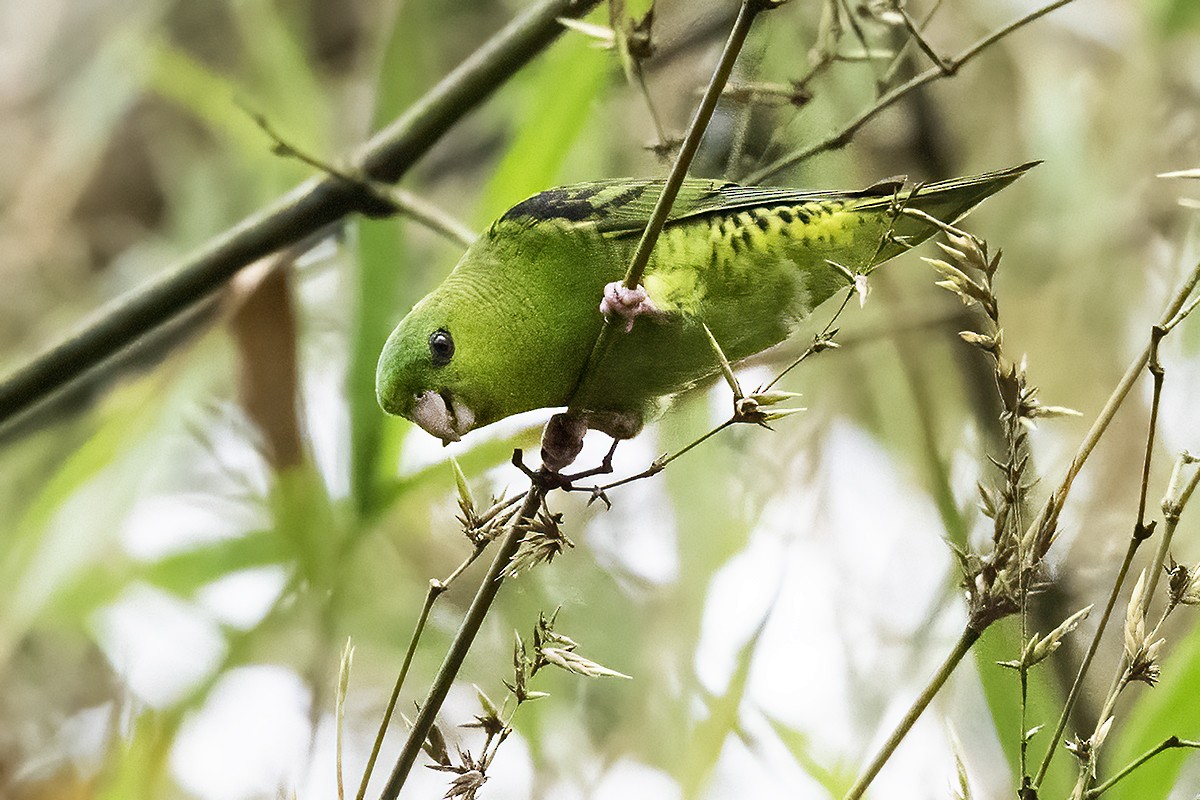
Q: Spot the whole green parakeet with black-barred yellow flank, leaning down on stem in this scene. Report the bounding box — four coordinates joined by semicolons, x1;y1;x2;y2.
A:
376;164;1033;469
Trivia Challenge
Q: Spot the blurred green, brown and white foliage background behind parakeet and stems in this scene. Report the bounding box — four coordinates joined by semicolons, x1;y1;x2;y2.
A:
0;0;1200;800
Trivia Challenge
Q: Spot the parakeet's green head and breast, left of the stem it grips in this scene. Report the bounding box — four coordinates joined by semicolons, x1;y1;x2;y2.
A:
376;229;600;441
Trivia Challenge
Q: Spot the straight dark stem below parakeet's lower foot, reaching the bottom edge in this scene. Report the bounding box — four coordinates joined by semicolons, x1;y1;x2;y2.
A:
379;485;545;800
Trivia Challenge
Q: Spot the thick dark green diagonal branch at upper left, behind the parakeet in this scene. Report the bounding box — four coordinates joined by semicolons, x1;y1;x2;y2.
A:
0;0;599;425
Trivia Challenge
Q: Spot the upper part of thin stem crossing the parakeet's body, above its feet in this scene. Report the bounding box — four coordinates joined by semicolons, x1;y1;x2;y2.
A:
571;0;775;410
